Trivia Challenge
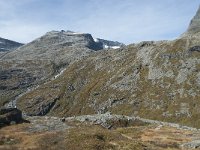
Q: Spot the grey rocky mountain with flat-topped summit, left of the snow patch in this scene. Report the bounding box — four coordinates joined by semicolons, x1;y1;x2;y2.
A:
0;30;124;106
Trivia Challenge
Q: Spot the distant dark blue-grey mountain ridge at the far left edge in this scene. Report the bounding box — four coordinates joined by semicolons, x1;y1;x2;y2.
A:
0;38;23;52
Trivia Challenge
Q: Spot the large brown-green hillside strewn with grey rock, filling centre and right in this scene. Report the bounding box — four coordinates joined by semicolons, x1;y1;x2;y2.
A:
14;5;200;127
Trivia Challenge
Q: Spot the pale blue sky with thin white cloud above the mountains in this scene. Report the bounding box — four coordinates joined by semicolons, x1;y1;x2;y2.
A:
0;0;200;44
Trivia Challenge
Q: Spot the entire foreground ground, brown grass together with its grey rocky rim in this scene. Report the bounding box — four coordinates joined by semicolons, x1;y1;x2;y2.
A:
0;113;200;150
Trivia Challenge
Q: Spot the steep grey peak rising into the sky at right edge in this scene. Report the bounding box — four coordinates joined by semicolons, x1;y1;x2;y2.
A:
186;6;200;34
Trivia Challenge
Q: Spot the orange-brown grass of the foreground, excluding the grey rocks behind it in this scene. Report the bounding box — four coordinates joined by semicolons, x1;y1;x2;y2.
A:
0;119;196;150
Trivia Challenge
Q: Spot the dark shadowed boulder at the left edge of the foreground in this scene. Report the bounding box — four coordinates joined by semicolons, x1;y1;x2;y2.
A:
0;108;23;125
